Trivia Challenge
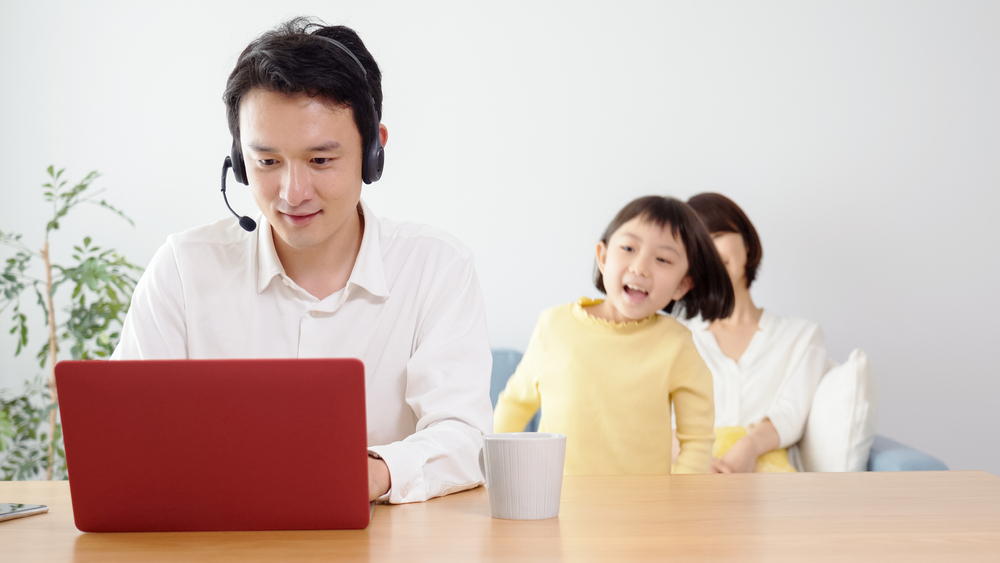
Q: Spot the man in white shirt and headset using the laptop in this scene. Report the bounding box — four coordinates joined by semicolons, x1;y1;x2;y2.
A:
113;19;492;503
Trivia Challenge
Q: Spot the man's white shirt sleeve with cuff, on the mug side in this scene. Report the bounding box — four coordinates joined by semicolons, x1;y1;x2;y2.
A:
368;256;493;503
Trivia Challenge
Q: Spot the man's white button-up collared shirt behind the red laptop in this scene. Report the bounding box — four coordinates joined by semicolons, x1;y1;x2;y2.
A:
112;201;493;503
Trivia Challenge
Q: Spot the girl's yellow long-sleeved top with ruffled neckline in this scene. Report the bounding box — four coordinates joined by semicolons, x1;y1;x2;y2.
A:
493;297;715;475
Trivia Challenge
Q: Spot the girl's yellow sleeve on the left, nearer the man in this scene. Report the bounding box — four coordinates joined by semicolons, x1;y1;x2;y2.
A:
493;326;545;432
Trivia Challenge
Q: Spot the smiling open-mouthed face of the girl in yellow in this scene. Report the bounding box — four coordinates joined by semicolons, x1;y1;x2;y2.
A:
597;216;691;322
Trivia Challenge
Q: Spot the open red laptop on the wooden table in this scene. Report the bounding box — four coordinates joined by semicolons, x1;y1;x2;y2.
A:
56;359;371;532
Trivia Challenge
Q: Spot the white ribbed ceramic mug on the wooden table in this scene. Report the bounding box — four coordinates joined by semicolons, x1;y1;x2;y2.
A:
479;432;566;520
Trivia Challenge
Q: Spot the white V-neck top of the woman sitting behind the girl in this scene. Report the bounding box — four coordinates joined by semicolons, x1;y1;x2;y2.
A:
678;310;826;448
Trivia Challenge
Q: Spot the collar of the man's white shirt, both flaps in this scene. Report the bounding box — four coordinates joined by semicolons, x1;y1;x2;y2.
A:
257;200;389;297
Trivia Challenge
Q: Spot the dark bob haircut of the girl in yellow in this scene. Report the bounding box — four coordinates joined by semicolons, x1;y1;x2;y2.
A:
594;196;735;321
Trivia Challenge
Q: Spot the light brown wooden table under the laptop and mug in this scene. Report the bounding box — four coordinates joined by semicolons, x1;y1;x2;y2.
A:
0;471;1000;563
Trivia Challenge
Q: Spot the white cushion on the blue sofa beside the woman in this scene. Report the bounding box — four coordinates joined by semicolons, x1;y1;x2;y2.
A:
797;349;878;471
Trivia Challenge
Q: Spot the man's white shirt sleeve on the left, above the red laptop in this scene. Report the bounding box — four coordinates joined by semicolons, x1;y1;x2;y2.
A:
111;238;188;360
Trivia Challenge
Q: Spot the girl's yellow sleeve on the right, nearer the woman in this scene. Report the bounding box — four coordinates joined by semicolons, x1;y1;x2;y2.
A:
667;334;715;473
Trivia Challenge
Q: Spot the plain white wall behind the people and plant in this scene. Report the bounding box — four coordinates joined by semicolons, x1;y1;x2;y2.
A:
0;0;1000;474
